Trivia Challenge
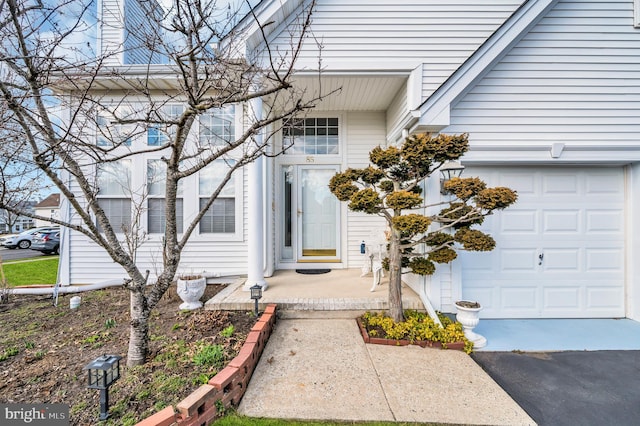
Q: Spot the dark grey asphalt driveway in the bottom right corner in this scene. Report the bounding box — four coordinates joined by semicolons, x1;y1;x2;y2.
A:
473;351;640;426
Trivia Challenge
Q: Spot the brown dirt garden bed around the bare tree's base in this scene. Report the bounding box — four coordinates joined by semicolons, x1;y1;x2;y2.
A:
0;285;256;425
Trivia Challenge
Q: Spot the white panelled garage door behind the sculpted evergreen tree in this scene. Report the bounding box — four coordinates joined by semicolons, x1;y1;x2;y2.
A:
460;167;625;318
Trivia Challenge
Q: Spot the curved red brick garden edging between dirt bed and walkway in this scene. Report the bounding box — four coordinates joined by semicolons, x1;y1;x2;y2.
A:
136;304;276;426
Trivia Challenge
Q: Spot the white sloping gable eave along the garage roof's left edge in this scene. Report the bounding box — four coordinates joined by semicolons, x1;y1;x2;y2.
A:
416;0;558;133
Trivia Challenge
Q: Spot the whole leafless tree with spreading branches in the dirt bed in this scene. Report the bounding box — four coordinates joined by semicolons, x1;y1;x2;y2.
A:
0;0;330;365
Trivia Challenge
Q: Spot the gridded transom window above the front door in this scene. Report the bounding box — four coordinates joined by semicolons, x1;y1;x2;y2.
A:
282;118;339;155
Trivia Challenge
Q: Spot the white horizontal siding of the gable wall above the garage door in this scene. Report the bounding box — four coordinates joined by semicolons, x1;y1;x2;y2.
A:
445;1;640;147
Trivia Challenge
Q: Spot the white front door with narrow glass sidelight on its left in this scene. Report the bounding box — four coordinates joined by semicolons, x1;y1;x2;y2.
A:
280;165;340;263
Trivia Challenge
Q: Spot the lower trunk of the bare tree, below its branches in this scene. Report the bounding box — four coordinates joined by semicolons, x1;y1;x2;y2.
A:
127;290;151;367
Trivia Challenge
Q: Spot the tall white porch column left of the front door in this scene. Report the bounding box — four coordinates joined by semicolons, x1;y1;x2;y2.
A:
243;98;267;291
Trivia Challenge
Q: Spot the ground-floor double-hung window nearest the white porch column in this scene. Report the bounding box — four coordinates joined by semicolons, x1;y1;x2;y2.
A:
198;160;237;234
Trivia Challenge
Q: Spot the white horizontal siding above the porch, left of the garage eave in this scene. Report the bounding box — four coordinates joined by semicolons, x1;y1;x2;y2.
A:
264;0;522;77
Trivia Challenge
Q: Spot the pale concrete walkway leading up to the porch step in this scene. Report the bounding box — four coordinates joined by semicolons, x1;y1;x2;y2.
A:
238;319;535;426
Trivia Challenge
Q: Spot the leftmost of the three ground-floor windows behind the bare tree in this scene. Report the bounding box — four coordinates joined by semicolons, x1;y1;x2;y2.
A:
96;159;131;232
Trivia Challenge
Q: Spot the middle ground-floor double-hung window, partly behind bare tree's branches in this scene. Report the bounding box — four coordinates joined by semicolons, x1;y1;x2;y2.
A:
147;159;184;234
